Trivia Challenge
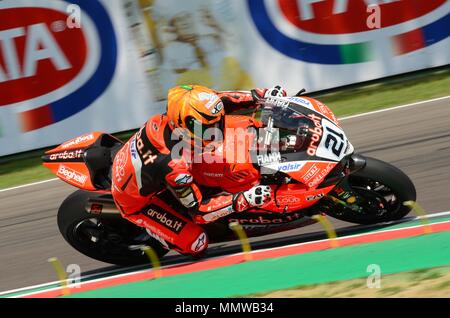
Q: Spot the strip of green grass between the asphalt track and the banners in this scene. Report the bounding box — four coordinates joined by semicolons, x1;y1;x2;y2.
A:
0;67;450;189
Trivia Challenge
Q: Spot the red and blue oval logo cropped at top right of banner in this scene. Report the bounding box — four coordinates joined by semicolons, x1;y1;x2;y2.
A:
247;0;450;65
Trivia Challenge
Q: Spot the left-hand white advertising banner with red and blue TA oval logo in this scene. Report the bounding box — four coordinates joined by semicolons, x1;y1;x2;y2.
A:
0;0;156;155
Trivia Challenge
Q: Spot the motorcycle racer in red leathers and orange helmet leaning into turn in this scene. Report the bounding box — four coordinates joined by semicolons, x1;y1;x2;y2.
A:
111;85;286;255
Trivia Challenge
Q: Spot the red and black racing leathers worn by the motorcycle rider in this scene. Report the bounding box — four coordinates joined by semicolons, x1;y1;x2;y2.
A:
112;89;266;254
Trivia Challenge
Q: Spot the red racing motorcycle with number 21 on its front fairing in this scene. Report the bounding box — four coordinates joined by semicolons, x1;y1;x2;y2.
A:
42;92;416;265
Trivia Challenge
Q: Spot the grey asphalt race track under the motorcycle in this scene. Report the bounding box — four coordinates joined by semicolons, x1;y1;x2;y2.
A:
0;99;450;291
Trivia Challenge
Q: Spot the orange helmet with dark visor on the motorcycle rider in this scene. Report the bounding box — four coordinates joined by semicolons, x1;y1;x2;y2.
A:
167;85;225;140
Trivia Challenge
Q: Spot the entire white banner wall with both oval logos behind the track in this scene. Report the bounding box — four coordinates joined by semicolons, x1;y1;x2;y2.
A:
0;0;450;156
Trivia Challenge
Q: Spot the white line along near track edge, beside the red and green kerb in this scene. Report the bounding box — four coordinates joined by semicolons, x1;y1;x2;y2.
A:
0;211;450;297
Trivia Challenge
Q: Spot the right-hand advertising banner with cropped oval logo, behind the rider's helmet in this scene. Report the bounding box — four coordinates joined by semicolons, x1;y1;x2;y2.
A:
124;0;450;99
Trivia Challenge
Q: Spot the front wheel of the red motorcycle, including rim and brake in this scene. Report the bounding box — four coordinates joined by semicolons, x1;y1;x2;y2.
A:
324;157;416;224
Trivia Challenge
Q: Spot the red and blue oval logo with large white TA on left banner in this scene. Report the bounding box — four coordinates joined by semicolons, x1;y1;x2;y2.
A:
0;0;117;132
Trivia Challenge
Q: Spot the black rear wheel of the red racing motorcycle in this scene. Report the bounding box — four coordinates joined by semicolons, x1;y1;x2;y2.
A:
58;190;168;266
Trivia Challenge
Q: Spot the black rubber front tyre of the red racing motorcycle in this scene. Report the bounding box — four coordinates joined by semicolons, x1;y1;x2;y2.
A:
326;157;416;224
